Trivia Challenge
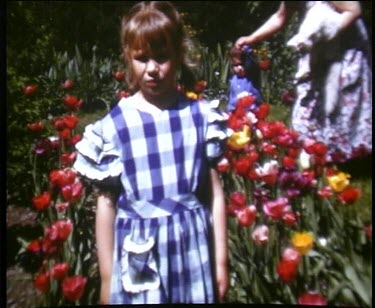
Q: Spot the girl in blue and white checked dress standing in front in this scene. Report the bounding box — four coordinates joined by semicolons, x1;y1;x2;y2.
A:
74;1;228;304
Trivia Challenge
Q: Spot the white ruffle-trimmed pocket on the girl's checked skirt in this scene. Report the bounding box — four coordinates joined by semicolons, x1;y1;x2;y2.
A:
121;235;160;293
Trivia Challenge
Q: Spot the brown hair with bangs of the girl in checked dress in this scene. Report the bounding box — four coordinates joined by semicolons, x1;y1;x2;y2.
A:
121;1;195;91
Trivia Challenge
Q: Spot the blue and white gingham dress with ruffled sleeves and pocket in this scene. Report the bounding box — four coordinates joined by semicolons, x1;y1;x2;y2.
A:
74;95;226;304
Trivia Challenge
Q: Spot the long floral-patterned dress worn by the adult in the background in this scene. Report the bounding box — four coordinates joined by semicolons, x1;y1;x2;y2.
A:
286;1;372;162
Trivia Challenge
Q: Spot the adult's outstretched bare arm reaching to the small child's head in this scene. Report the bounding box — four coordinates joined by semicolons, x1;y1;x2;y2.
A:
235;1;291;49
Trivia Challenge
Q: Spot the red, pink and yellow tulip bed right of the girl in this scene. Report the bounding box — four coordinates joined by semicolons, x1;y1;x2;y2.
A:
218;95;372;307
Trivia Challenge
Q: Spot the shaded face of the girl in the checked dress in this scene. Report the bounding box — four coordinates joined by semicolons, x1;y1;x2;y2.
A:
129;49;176;98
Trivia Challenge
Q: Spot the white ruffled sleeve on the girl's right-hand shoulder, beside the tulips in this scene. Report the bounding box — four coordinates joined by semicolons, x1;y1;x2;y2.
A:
206;99;231;166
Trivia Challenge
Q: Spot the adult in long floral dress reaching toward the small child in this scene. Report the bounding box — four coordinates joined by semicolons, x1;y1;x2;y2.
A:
235;1;372;163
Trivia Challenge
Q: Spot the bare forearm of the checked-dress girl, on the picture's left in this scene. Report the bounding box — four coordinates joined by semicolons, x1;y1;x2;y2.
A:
95;194;115;304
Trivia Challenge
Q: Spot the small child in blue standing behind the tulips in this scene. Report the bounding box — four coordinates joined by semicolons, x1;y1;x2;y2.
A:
227;46;264;112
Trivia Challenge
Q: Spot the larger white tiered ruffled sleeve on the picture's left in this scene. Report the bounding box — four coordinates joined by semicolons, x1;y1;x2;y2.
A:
73;116;123;181
